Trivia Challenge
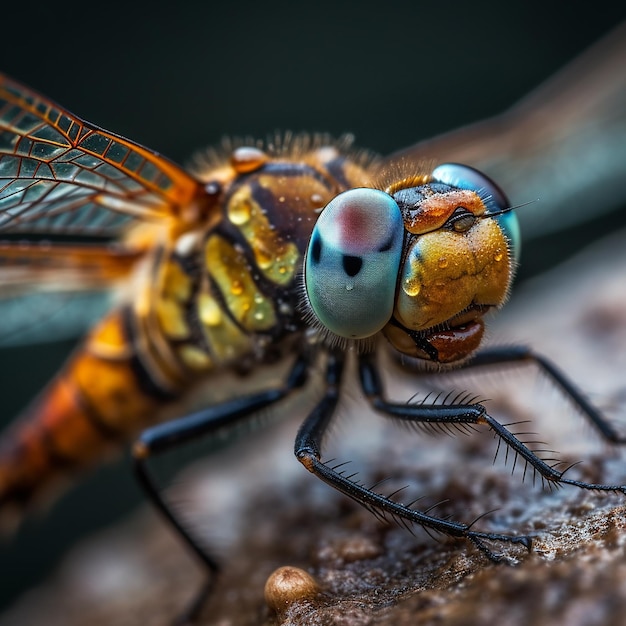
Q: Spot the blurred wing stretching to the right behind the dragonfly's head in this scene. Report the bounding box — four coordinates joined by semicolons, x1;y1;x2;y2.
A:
382;24;626;239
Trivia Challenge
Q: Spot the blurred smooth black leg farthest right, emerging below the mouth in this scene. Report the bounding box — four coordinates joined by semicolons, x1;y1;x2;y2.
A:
465;346;626;444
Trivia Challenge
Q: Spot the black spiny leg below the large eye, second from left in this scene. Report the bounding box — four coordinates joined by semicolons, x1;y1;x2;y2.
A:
294;355;531;561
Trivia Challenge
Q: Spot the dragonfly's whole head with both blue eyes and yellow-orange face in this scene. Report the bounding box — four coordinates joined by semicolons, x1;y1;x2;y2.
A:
304;163;520;364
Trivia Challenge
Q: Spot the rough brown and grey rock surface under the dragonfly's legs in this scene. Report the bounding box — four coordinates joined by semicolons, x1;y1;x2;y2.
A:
0;232;626;626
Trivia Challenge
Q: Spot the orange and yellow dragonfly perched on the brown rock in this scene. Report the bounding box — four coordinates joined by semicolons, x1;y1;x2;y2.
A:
0;22;626;620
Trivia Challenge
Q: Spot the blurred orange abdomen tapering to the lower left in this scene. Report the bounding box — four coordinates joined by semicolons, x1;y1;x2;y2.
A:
0;310;178;512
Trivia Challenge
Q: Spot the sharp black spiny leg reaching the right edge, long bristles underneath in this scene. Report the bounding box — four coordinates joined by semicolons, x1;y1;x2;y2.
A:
359;355;626;494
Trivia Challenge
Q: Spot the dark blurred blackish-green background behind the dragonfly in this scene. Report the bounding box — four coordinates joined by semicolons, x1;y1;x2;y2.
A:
0;0;626;608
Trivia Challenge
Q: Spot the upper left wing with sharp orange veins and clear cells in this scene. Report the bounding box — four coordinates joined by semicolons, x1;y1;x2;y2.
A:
0;75;204;237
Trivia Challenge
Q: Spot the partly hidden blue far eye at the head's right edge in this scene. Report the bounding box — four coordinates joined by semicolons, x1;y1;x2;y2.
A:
432;163;522;262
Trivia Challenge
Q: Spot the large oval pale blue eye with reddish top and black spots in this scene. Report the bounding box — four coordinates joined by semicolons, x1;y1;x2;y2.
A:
304;189;404;339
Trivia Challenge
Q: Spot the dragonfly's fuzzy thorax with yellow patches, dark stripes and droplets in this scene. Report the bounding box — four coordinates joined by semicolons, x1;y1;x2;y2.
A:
144;139;376;376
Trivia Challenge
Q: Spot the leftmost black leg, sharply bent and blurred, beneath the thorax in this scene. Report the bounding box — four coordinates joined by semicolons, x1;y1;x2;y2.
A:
132;348;310;624
